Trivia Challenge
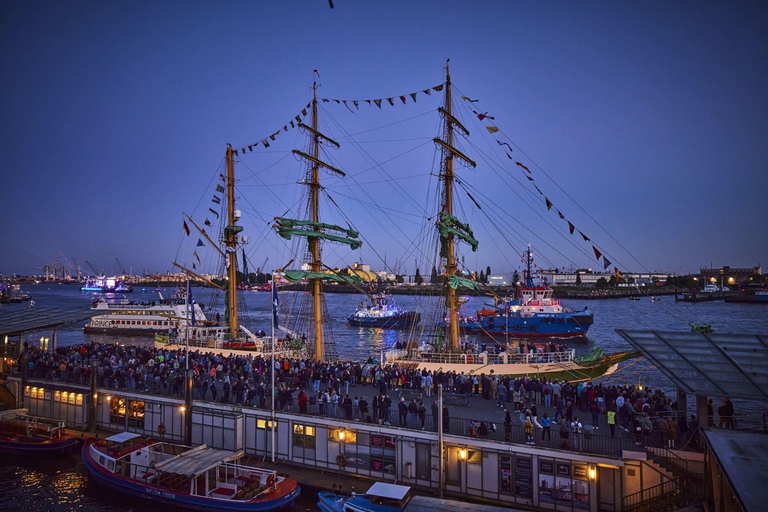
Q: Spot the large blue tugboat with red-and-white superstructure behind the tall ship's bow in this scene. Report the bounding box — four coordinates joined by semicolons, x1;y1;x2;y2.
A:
459;246;593;338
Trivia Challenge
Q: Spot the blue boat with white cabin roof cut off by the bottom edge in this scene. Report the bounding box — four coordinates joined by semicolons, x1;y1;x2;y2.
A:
317;482;513;512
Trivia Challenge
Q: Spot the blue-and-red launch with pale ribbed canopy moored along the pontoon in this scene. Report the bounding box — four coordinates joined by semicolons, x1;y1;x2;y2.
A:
82;432;301;512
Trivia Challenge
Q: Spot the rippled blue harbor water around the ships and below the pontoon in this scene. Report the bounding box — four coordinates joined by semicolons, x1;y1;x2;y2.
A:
0;284;768;512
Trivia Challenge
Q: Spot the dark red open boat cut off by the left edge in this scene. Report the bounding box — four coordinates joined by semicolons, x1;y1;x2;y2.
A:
0;409;77;455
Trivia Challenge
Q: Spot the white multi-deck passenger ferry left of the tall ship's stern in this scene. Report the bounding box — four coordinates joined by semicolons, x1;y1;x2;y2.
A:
83;290;207;336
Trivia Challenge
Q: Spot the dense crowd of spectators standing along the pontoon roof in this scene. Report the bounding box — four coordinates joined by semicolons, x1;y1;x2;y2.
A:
15;343;734;447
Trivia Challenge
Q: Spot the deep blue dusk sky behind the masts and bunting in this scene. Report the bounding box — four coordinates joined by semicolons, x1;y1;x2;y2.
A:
0;0;768;275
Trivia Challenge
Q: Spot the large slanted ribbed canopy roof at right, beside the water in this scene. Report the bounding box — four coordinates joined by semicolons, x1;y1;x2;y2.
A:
616;329;768;401
